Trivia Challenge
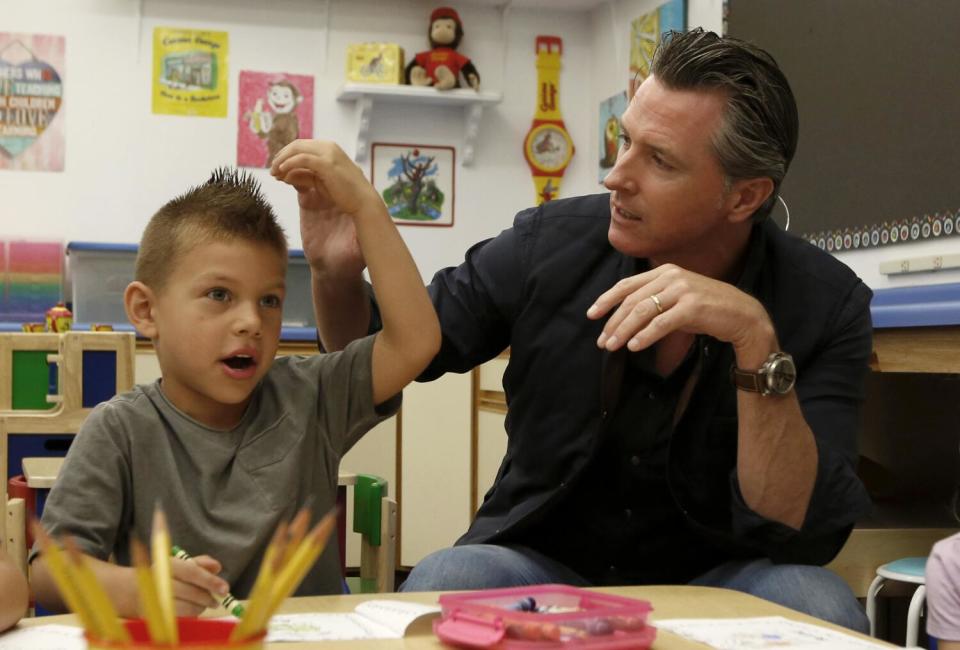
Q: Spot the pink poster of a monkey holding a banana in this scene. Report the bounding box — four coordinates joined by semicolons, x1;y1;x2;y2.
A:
237;70;313;167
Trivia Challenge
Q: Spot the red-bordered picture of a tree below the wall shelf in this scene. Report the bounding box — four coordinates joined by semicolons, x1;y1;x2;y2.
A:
370;142;456;227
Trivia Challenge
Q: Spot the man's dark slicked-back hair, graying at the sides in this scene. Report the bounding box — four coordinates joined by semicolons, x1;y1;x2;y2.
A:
650;28;800;221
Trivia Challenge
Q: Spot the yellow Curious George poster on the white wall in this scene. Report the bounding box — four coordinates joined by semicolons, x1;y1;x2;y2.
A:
153;27;229;117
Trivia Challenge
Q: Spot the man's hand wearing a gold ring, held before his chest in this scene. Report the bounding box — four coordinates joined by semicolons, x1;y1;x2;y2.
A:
587;264;774;365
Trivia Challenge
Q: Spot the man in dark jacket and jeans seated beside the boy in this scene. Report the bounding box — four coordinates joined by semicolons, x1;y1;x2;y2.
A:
304;29;871;630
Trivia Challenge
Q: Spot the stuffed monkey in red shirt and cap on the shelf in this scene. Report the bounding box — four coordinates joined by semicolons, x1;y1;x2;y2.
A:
406;7;480;90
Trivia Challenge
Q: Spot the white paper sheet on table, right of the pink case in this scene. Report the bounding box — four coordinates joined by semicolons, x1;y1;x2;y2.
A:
653;616;889;650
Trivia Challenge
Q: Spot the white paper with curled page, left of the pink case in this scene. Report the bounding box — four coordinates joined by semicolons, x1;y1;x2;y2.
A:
264;600;440;636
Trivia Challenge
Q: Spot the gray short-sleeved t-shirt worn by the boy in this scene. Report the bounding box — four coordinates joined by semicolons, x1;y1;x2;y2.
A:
36;336;400;598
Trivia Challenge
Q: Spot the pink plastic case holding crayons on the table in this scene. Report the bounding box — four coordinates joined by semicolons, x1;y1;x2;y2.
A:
433;585;657;650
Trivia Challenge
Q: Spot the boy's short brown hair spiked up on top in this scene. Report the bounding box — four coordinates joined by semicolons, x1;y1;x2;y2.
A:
135;167;287;291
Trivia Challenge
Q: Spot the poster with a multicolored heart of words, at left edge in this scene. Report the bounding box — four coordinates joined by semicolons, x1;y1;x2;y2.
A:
0;32;66;172
